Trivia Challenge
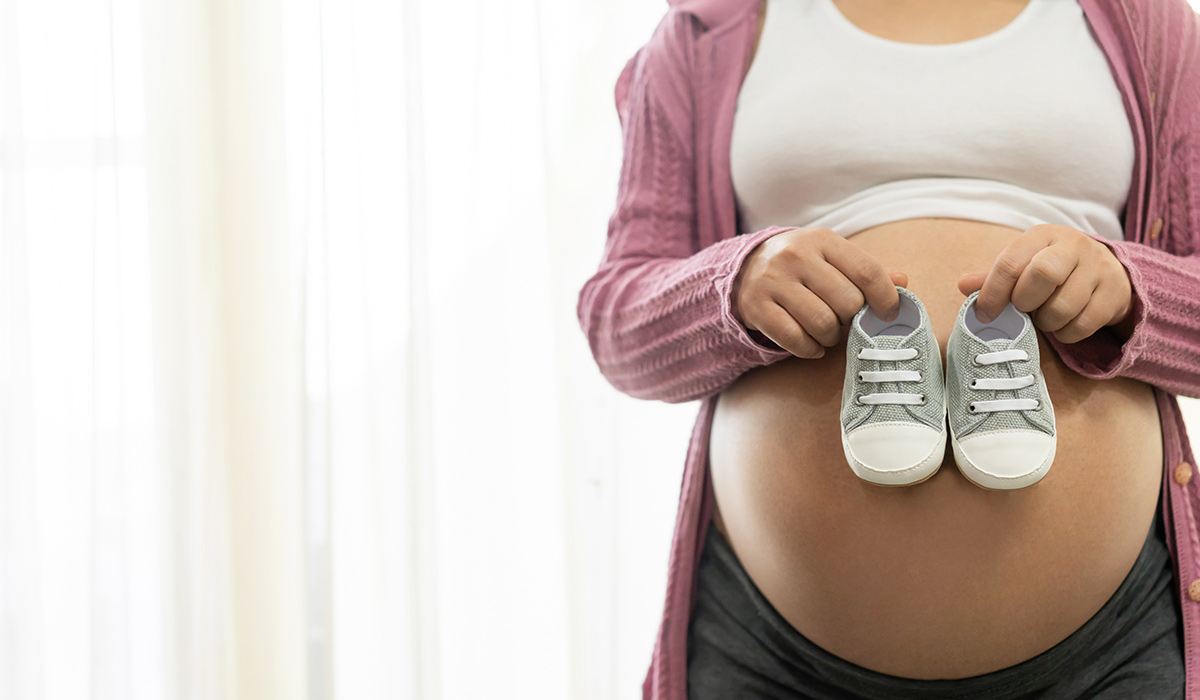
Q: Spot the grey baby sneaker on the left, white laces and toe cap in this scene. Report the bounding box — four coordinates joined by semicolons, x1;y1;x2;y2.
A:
841;287;946;486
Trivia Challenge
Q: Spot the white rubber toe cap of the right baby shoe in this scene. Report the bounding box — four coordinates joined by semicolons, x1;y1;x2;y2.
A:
952;431;1057;489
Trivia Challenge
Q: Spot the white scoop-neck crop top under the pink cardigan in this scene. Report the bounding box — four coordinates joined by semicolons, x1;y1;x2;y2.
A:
730;0;1134;240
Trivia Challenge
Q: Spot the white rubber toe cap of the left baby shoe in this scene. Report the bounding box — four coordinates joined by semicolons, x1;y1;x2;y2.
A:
842;423;946;486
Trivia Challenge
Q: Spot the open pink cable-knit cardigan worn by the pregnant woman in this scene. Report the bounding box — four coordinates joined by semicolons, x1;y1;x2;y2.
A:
577;0;1200;700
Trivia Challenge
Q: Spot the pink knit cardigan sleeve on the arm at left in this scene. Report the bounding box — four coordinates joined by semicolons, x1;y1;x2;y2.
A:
576;25;794;403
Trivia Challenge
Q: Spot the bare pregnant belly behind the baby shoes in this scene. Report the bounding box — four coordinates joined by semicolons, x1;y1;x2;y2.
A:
709;219;1163;678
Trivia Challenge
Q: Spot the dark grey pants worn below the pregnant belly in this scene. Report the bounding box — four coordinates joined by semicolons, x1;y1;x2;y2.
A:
688;501;1183;700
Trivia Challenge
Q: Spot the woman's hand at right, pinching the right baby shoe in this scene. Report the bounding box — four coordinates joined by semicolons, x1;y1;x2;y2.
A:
959;223;1133;343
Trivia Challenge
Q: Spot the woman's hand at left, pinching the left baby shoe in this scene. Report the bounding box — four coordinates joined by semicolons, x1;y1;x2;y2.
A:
732;228;908;359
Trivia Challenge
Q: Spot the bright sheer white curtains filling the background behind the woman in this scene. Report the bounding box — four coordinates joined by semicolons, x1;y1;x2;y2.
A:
0;0;1200;700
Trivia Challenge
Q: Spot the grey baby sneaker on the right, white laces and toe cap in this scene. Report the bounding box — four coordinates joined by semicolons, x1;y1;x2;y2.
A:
946;292;1057;489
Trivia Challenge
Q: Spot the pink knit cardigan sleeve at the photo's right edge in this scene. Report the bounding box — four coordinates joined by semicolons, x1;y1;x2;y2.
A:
1046;0;1200;396
